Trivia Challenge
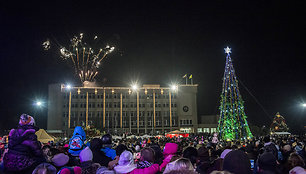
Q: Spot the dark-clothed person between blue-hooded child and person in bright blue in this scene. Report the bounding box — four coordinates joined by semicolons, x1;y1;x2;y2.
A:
89;138;112;167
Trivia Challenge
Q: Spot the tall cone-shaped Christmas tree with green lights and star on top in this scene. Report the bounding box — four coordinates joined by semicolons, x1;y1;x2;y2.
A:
218;47;253;141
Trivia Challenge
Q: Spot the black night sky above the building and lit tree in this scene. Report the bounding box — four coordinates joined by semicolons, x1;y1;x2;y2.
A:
0;0;306;131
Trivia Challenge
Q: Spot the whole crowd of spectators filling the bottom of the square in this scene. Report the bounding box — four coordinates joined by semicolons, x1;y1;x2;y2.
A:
0;114;306;174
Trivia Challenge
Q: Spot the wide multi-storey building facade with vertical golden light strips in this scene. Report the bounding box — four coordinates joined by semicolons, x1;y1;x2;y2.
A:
48;84;198;134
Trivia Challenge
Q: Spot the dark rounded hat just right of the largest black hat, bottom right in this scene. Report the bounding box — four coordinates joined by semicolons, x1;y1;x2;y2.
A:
258;152;277;171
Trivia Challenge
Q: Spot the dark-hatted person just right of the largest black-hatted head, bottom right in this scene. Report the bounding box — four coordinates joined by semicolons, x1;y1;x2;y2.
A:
254;152;278;174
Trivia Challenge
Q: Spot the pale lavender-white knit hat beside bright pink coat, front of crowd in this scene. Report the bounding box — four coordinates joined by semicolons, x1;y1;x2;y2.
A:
114;150;137;173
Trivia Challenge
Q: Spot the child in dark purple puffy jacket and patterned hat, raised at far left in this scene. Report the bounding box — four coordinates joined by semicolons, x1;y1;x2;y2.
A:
3;114;44;173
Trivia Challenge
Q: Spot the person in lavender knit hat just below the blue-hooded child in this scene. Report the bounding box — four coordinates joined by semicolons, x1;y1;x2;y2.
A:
79;147;101;174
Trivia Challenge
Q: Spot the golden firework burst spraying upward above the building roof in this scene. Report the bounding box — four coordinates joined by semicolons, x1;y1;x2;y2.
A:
60;33;115;83
